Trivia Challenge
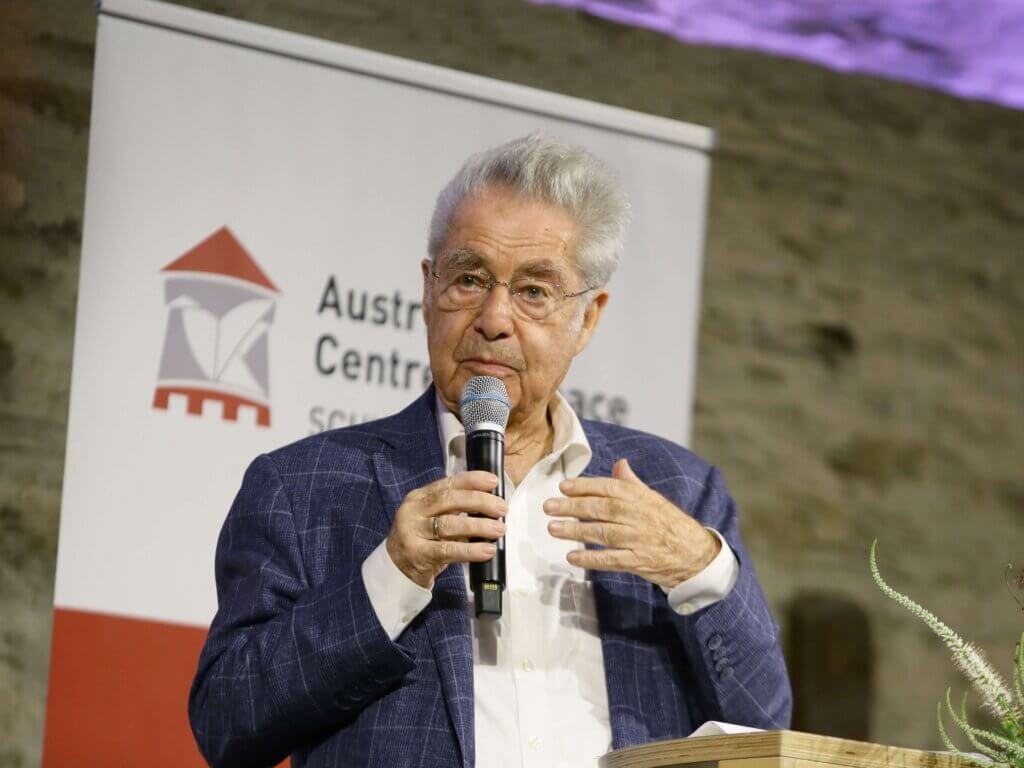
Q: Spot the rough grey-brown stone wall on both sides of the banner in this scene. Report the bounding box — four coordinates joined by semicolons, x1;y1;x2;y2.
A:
0;0;1024;767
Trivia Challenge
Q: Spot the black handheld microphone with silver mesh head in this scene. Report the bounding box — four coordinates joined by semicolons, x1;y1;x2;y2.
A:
459;376;512;620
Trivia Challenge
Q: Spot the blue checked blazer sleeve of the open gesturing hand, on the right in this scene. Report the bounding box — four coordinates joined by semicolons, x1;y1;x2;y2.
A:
672;467;793;730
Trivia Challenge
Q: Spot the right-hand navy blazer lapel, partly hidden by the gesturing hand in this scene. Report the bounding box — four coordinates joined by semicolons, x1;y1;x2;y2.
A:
583;422;653;750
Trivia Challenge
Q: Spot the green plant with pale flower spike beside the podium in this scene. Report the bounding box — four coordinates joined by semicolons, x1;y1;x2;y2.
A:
868;540;1024;768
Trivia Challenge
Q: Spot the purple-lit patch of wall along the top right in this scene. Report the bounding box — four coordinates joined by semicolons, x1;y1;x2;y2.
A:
531;0;1024;109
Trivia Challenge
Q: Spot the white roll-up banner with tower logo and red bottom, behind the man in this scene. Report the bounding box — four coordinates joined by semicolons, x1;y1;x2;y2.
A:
44;0;714;768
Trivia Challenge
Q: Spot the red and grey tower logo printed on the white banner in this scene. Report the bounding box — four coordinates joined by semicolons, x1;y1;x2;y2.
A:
153;226;280;427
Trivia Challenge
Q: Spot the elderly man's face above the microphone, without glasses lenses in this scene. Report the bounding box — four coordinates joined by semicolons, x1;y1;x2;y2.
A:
423;186;608;424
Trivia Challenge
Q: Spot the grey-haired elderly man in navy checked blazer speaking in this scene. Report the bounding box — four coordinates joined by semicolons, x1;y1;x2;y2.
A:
189;135;791;768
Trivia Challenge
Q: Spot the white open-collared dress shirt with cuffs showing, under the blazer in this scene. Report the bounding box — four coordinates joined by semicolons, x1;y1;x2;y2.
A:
362;394;739;768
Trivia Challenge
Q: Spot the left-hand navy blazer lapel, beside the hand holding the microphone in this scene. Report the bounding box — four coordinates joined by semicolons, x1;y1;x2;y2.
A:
374;386;475;765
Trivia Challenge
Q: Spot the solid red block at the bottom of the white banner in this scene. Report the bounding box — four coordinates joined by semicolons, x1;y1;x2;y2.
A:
43;608;287;768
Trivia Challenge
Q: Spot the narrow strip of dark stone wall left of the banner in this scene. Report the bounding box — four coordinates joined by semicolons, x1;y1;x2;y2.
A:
0;2;95;768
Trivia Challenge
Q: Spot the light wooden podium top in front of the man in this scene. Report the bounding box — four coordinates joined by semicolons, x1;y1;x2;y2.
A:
599;731;970;768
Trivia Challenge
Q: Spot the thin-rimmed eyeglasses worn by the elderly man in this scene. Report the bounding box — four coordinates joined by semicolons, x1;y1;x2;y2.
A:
430;267;594;321
